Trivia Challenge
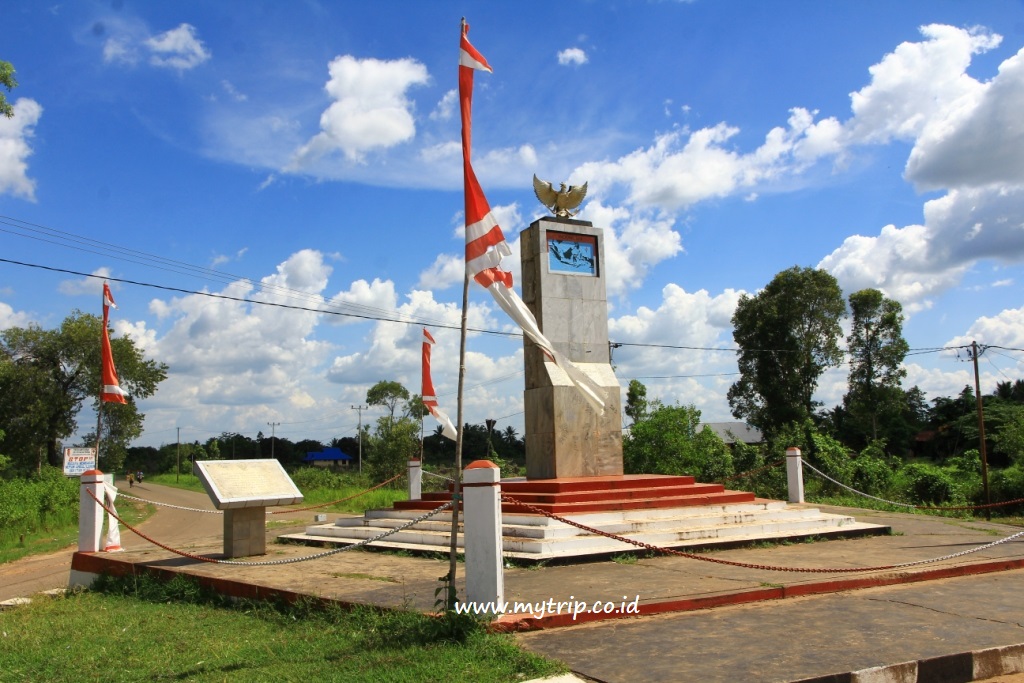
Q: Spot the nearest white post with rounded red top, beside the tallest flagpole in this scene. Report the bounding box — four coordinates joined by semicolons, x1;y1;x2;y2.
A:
462;460;505;616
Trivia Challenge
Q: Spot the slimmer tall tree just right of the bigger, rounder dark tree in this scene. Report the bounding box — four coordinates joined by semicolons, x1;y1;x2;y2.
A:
843;289;910;446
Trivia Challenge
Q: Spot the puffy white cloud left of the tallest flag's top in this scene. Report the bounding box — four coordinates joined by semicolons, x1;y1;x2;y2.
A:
295;54;429;167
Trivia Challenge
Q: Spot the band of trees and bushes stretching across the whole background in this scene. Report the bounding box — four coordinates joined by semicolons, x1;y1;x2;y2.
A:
0;267;1024;511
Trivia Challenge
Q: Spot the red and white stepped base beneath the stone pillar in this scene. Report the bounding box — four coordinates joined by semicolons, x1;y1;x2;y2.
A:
282;474;890;560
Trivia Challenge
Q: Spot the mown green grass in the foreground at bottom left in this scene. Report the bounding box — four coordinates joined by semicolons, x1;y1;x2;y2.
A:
0;577;565;683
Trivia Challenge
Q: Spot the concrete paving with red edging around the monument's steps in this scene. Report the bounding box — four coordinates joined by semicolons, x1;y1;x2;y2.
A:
56;499;1024;683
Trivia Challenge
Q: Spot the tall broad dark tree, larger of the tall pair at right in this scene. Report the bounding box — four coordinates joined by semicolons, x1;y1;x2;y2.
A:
728;266;846;437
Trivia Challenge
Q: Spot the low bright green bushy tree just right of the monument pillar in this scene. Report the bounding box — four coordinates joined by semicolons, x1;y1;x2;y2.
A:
623;400;733;481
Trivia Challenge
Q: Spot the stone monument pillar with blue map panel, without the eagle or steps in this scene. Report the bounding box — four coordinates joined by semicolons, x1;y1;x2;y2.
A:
520;216;623;479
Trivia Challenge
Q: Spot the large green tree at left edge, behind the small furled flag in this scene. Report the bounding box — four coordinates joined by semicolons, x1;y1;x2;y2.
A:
0;310;167;471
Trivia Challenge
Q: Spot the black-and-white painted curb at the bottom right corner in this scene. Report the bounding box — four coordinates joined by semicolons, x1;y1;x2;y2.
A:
791;643;1024;683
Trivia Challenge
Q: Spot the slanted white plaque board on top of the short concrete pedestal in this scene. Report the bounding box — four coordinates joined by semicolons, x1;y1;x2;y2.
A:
196;459;302;510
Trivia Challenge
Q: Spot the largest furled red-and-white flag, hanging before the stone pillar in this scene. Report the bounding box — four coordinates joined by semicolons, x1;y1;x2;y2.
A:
459;20;604;413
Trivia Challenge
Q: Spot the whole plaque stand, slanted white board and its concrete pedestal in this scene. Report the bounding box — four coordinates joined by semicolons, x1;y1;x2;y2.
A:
196;460;303;557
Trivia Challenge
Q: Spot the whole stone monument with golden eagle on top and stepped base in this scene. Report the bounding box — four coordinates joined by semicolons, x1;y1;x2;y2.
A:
285;175;887;566
